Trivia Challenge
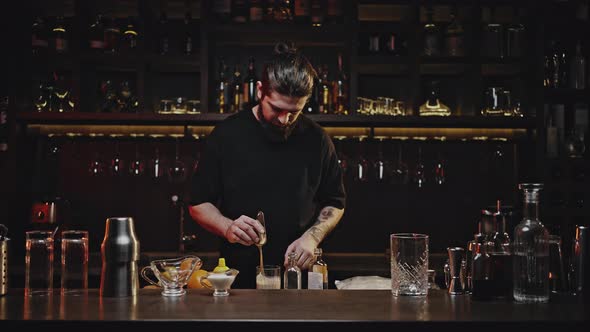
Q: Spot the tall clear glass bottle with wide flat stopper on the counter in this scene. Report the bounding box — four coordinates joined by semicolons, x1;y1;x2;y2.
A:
513;183;549;302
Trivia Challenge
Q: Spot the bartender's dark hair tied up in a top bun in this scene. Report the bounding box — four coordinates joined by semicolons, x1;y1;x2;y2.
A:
261;43;317;97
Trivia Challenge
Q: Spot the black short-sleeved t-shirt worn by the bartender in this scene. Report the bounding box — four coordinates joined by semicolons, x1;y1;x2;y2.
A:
190;110;346;288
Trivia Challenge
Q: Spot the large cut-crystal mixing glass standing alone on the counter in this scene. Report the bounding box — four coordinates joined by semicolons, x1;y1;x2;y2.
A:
390;233;428;296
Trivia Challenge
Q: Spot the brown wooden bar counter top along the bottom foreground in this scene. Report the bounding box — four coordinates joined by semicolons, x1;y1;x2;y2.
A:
0;289;589;332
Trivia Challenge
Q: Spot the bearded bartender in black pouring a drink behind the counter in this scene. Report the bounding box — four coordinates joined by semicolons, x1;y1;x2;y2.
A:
189;43;346;288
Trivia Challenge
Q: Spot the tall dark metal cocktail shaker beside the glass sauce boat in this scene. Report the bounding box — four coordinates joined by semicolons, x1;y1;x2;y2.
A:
100;217;139;297
